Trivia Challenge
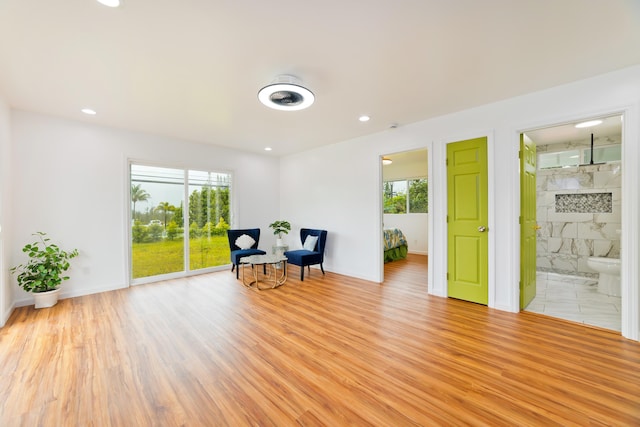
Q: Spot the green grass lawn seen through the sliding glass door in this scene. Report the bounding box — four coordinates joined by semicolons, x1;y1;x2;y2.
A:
131;236;230;279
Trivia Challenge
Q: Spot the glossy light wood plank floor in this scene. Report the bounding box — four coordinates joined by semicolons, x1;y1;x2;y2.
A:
0;256;640;426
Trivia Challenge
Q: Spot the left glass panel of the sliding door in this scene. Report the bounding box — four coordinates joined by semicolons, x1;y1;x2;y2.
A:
131;165;184;279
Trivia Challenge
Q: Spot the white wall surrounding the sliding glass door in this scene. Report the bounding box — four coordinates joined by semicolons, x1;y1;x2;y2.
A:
9;111;280;305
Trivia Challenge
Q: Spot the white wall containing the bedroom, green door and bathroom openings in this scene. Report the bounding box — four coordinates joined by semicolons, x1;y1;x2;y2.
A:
281;66;640;339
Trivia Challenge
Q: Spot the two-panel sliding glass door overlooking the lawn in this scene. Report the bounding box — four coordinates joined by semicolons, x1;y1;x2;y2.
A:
130;164;231;281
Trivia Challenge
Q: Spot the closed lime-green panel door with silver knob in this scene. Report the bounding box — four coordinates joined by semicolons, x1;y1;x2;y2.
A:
447;137;489;305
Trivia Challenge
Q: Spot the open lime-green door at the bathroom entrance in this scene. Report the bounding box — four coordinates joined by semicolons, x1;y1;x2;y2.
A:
520;134;538;309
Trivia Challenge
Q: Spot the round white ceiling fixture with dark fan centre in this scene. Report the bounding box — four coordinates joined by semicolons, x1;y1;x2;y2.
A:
258;74;315;111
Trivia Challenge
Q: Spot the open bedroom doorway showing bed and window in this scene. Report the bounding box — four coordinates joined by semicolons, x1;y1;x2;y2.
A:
381;148;429;285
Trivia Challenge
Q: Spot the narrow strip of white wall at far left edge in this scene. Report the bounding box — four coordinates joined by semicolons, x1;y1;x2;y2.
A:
0;98;13;326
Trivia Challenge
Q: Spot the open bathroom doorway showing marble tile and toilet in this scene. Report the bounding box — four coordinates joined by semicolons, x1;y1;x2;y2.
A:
521;114;623;332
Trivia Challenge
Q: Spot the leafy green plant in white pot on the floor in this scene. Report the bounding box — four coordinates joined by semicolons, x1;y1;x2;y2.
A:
10;231;78;308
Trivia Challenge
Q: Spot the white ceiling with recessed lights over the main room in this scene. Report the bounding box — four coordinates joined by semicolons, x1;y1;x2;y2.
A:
0;0;640;156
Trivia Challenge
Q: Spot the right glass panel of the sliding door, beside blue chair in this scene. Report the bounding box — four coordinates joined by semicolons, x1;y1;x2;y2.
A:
189;171;231;270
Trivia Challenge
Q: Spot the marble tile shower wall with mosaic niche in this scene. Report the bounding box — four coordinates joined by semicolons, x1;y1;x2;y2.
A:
536;162;622;277
